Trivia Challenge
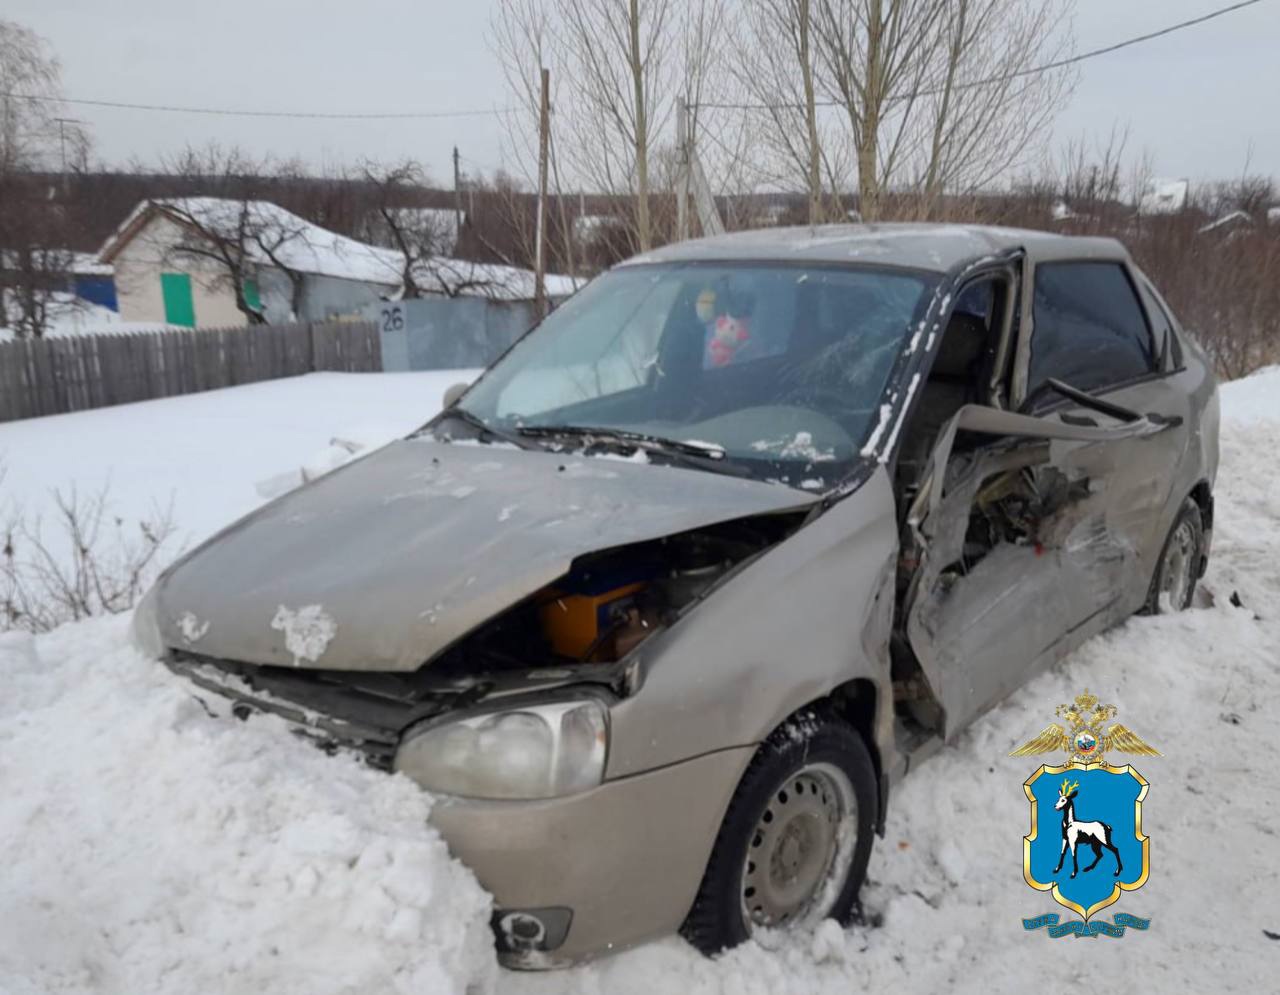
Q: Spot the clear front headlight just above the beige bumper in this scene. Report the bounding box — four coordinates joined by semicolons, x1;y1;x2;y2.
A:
396;698;609;799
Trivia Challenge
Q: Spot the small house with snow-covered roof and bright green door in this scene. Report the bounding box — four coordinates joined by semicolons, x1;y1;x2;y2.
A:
97;197;401;327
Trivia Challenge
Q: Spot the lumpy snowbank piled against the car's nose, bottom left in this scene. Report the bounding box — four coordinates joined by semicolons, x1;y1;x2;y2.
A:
0;619;497;995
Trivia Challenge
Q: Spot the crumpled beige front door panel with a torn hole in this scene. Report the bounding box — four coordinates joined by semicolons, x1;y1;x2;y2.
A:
899;409;1172;736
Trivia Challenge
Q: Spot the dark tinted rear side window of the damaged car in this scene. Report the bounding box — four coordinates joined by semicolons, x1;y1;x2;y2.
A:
1027;263;1156;402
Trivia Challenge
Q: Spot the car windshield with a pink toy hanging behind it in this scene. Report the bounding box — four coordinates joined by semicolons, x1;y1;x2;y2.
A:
462;264;932;489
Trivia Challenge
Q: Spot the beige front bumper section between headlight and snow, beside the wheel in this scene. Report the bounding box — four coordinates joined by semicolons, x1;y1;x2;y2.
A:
430;747;753;968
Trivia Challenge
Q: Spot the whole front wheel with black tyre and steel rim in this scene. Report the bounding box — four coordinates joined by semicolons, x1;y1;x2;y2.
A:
681;708;878;954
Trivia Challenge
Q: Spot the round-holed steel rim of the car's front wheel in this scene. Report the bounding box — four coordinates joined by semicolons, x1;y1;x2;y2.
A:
742;763;858;928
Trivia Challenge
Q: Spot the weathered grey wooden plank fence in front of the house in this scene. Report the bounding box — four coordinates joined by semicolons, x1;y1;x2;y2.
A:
0;323;383;421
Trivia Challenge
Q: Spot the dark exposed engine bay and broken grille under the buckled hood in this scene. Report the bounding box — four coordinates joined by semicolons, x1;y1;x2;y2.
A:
169;512;805;770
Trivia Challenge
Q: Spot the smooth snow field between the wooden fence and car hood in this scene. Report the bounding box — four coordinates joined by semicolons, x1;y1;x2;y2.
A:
0;370;476;552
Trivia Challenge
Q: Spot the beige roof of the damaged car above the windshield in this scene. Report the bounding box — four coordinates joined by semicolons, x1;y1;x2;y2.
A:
622;224;1129;273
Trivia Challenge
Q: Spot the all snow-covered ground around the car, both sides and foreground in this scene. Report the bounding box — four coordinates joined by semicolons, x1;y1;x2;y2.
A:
0;369;1280;995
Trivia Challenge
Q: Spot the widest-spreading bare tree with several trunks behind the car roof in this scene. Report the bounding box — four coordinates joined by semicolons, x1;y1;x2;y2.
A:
756;0;1074;220
